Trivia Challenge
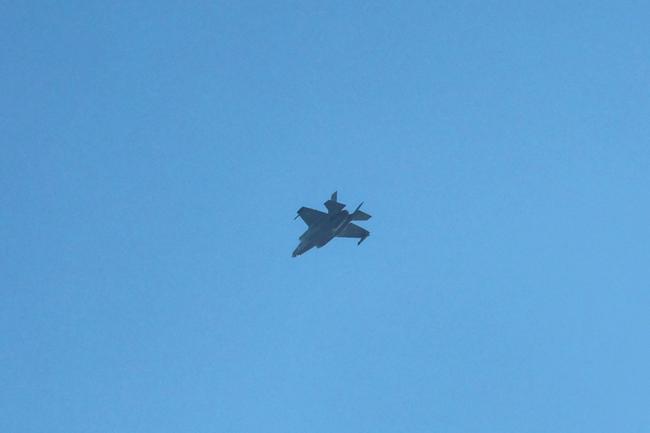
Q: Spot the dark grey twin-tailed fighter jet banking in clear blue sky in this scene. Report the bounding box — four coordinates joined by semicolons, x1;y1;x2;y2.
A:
291;191;370;257
